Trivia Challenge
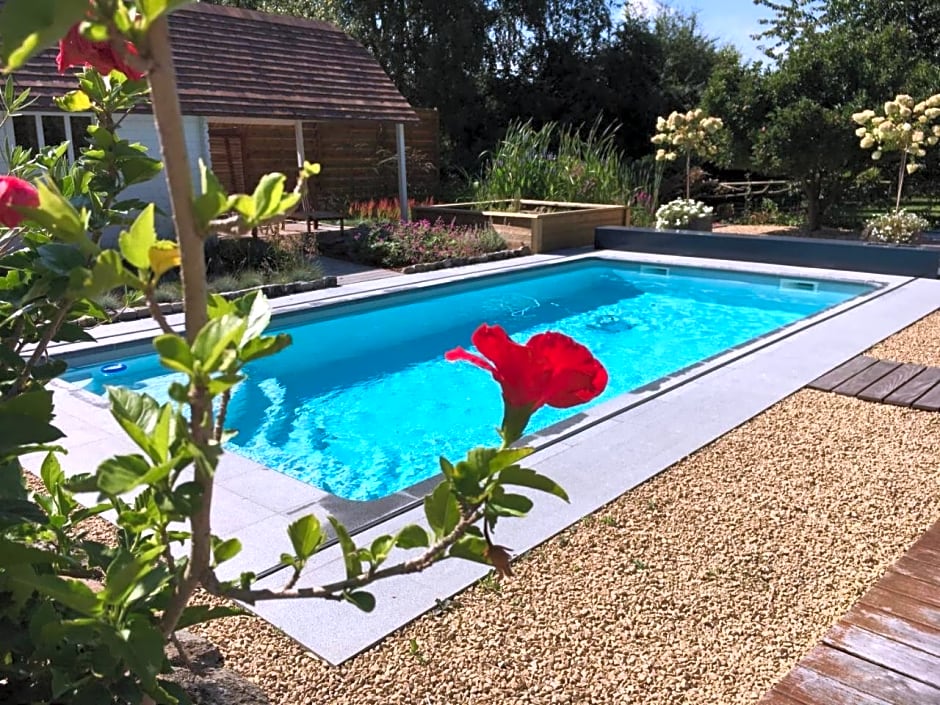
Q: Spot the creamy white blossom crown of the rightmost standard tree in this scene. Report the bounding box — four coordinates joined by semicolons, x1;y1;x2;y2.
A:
852;93;940;174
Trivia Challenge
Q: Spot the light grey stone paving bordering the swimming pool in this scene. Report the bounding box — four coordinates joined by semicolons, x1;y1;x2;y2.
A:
25;251;940;663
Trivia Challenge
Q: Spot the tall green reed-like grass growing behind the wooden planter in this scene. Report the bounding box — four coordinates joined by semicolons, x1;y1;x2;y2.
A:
474;119;658;205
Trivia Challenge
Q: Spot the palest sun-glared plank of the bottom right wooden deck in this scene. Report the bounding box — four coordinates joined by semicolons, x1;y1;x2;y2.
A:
823;621;940;684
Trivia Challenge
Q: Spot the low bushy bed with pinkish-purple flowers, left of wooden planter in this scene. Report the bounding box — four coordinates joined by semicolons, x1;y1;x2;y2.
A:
348;220;506;267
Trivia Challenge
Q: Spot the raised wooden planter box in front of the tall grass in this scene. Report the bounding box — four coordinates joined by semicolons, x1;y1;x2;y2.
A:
411;199;627;253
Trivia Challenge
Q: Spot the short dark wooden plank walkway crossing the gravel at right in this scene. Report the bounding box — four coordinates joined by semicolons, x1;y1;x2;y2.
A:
808;355;940;411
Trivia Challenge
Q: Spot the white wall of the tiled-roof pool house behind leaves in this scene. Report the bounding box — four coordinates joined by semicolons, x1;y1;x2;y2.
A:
119;114;211;237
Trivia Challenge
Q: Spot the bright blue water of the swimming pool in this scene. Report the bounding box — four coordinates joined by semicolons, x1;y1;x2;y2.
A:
65;259;871;500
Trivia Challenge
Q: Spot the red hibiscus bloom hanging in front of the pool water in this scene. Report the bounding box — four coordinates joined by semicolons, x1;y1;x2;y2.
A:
444;323;607;443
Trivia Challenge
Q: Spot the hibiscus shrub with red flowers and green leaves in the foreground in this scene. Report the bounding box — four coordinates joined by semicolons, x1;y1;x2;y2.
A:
0;0;607;705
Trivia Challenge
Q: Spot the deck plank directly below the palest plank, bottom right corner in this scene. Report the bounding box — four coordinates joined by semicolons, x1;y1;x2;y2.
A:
801;645;940;705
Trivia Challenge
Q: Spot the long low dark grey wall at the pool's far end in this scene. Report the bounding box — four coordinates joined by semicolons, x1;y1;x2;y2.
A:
594;226;940;279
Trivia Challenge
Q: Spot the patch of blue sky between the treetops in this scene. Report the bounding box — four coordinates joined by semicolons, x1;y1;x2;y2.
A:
629;0;770;61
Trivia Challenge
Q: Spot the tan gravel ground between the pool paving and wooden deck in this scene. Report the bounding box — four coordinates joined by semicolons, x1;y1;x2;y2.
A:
23;306;940;705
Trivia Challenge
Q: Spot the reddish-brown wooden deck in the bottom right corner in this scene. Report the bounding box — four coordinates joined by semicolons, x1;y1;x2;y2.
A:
760;516;940;705
